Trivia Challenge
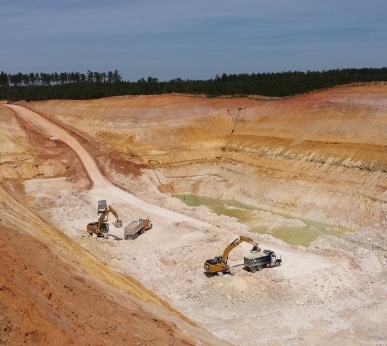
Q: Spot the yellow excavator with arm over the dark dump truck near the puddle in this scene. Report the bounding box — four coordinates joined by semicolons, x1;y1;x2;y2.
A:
204;235;261;276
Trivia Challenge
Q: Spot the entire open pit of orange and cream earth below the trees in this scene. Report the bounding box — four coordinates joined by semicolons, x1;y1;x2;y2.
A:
0;83;387;346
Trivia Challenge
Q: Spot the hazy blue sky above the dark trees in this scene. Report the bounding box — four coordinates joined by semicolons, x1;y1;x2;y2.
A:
0;0;387;81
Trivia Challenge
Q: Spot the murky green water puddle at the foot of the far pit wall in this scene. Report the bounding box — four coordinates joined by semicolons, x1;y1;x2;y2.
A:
175;195;350;246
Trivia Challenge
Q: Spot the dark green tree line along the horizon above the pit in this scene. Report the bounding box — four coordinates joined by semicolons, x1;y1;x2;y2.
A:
0;67;387;101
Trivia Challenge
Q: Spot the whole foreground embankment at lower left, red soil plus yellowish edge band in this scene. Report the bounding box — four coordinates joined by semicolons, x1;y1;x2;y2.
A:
0;187;202;345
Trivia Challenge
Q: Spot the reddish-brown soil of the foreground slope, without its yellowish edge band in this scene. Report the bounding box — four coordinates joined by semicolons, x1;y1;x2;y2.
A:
0;223;194;345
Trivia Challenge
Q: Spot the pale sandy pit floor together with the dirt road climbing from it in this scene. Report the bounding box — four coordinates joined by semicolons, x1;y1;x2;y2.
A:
3;100;387;345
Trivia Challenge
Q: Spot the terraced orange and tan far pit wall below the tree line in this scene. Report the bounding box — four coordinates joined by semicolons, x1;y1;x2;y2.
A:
26;83;387;235
